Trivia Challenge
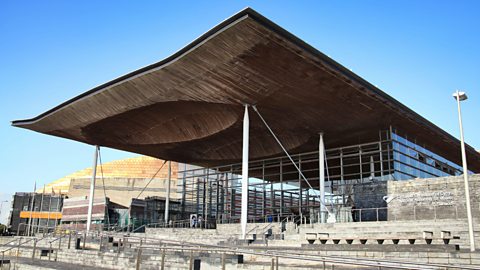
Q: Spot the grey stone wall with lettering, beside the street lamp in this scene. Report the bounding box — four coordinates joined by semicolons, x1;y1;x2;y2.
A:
388;174;480;220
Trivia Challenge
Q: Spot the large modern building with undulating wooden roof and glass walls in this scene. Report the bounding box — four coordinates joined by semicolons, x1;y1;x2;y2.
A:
13;8;480;228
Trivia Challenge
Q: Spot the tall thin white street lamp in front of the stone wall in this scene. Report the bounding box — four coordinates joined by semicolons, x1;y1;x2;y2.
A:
453;90;475;251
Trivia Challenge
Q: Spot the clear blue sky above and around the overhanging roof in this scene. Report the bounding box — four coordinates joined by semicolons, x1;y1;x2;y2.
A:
0;0;480;222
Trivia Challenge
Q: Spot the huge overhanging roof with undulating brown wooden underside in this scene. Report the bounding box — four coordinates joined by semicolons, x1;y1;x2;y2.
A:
13;9;480;171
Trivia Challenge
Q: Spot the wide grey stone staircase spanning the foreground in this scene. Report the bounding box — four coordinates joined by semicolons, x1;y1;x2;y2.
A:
0;220;480;269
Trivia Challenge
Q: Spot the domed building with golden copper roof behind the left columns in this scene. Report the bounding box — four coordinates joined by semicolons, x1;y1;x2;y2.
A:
47;156;184;229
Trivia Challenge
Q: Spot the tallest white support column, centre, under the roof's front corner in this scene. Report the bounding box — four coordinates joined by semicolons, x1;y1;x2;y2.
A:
240;105;250;239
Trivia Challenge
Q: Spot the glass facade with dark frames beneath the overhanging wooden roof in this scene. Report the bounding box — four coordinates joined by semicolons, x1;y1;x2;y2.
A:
178;128;468;222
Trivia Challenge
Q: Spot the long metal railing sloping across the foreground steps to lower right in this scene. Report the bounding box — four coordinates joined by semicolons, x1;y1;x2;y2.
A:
0;226;477;269
